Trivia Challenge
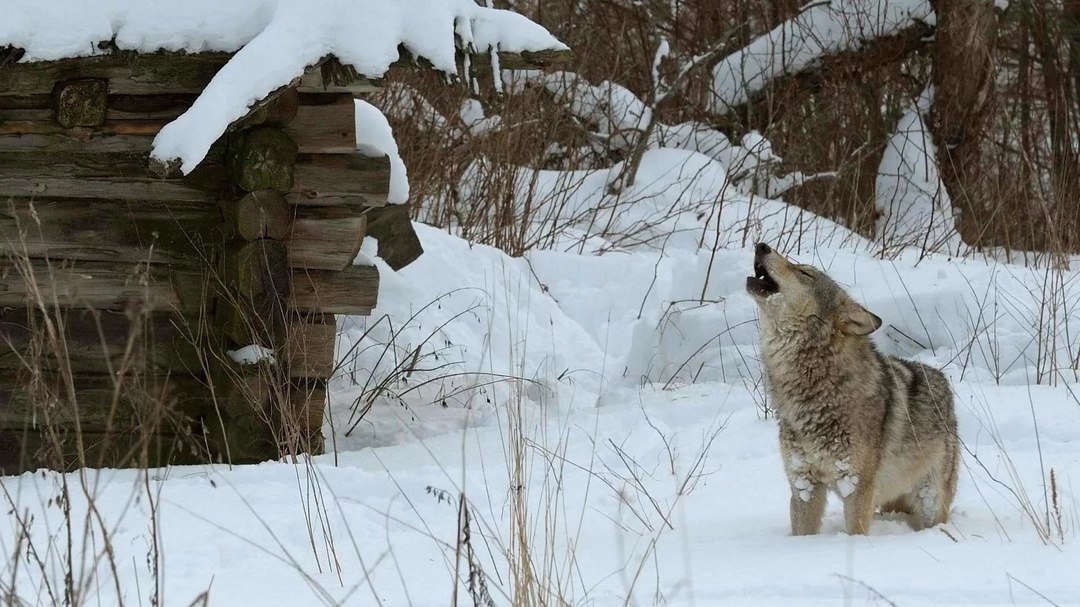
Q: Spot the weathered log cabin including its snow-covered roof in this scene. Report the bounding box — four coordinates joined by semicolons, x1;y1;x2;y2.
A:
0;0;567;474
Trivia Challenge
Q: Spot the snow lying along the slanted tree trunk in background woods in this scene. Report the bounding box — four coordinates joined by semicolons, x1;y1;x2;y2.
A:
712;0;934;114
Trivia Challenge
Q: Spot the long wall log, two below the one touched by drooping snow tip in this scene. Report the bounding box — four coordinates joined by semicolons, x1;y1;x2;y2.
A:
0;259;204;313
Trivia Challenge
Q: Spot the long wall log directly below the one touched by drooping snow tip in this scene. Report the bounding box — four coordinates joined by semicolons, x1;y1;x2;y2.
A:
0;198;224;266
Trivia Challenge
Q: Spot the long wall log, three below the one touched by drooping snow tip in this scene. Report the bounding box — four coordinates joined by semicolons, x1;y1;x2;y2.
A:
0;308;211;375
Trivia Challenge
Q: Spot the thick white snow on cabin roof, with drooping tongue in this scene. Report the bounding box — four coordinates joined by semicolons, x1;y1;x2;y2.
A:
0;0;567;173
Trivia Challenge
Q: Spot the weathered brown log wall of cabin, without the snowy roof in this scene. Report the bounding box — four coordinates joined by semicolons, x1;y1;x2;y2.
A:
0;53;388;473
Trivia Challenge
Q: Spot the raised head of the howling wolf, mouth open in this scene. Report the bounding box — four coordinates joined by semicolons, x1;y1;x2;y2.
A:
746;243;881;336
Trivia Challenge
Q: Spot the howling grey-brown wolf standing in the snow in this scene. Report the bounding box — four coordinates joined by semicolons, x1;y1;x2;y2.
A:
746;243;960;536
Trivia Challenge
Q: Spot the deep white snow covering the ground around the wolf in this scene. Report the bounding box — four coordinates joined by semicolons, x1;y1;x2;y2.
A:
0;60;1080;607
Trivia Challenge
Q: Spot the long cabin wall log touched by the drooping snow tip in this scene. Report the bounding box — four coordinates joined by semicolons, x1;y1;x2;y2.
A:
0;151;228;202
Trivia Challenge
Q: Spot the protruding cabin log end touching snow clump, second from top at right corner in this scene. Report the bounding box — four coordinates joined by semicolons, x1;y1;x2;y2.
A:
286;153;390;206
